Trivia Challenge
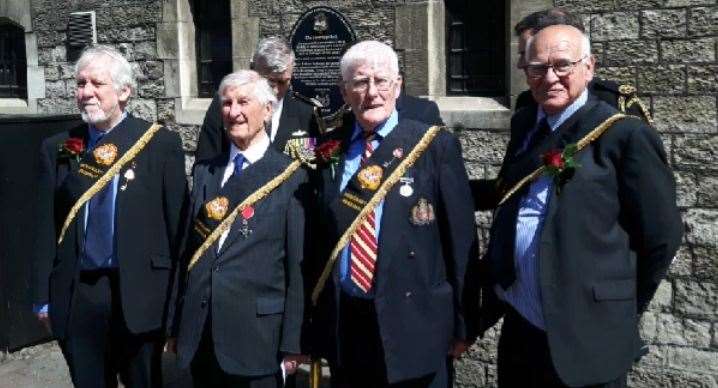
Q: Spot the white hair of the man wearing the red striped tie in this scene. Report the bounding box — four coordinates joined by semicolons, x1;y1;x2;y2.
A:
339;40;399;81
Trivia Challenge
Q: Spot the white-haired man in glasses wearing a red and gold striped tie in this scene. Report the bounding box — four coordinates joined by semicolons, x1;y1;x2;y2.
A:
312;41;477;387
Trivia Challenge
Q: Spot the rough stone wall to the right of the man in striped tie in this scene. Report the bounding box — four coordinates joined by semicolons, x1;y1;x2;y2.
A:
457;0;718;388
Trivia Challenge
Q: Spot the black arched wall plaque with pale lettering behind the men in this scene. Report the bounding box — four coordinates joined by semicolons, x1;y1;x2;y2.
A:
290;7;356;116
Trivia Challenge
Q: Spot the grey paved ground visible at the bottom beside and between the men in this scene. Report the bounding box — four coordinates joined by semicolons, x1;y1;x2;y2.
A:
0;342;329;388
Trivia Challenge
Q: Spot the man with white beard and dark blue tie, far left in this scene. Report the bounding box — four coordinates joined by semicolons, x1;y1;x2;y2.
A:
34;46;187;387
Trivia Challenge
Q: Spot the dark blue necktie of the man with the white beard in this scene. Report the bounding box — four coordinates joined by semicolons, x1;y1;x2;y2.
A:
85;134;115;268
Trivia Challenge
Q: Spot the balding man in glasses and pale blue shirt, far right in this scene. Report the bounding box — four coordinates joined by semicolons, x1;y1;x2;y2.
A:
481;25;682;387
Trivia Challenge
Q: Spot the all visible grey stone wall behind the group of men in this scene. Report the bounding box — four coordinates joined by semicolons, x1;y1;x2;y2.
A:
25;0;718;387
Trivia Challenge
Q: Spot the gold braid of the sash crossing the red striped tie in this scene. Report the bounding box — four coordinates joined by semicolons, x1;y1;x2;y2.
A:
312;125;441;305
